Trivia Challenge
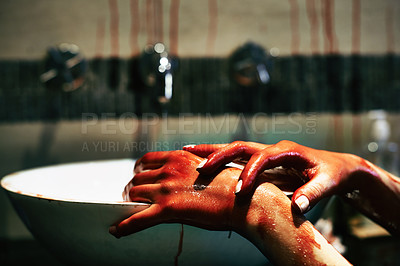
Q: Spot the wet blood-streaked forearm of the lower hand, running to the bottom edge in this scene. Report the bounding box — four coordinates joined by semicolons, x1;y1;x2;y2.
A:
231;183;349;265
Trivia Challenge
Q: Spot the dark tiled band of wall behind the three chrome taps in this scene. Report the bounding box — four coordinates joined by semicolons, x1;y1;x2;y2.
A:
0;55;400;121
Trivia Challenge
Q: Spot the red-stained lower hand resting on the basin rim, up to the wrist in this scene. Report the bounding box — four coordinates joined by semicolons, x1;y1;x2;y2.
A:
110;151;240;237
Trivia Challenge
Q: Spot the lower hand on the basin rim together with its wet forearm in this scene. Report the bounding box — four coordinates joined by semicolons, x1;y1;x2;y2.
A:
110;151;348;265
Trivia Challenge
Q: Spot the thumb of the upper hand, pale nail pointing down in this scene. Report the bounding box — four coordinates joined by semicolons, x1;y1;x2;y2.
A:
292;173;337;213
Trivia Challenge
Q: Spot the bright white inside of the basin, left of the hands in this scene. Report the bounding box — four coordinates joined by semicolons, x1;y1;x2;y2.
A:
1;159;142;204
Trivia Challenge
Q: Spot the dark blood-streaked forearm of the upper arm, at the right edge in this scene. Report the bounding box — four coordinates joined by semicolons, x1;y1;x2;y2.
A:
343;159;400;236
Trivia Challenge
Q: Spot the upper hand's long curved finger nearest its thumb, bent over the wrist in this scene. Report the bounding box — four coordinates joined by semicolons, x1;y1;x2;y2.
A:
236;144;307;195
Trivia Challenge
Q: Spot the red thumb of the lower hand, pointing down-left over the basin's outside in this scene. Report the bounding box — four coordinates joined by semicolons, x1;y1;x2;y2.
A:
109;204;162;238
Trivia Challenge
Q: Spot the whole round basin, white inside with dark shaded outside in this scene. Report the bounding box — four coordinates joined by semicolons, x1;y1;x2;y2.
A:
1;159;267;265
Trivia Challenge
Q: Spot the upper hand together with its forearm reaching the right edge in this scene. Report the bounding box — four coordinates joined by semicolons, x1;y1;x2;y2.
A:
184;141;400;235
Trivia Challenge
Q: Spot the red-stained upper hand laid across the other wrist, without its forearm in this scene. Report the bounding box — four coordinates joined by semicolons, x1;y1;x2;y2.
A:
184;141;366;212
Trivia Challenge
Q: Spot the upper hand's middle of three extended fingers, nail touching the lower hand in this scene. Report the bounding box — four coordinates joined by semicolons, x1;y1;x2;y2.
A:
198;141;260;174
